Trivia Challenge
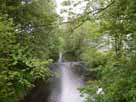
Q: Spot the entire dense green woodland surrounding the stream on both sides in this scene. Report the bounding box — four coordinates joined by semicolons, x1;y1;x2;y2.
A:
0;0;136;102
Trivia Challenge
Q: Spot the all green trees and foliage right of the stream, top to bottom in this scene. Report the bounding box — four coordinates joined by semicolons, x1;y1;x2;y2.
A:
60;0;136;102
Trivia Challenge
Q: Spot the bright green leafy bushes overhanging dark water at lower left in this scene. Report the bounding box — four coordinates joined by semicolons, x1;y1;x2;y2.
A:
0;16;50;102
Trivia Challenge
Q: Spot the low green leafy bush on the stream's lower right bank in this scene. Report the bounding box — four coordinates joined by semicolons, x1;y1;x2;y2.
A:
81;51;136;102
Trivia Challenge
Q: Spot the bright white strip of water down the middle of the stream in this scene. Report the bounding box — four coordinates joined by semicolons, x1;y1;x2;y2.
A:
60;63;83;102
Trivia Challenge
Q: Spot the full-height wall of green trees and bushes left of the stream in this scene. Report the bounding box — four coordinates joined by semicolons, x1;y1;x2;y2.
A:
0;0;58;102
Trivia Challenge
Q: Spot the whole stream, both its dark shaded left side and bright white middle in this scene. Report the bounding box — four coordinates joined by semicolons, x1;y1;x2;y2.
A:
20;53;83;102
